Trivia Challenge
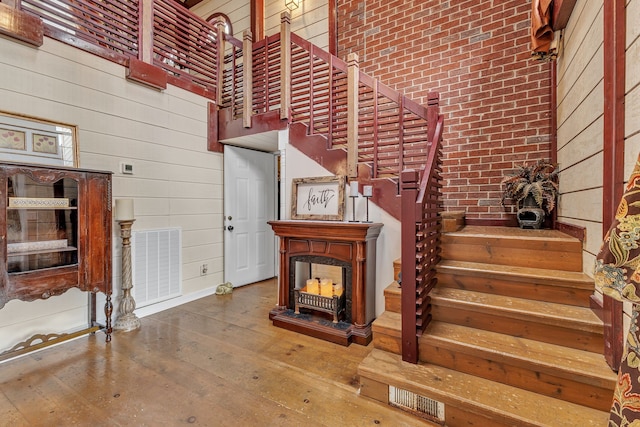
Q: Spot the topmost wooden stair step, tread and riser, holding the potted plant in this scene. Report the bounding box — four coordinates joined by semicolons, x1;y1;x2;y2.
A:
442;226;582;271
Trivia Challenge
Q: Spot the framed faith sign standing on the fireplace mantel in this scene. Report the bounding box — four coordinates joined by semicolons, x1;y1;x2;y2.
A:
291;176;345;221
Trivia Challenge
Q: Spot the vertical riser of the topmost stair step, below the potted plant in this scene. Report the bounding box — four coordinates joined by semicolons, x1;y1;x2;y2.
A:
442;239;582;271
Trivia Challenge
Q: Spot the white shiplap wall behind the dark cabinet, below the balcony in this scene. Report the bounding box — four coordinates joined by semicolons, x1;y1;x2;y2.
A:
0;38;223;352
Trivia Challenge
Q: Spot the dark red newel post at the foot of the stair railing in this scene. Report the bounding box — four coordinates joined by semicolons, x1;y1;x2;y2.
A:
400;169;420;363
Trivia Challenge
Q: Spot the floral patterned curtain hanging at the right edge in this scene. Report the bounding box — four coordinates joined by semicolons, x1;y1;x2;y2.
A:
594;153;640;427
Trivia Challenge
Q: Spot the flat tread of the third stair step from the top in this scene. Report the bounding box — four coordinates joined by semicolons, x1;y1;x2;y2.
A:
431;286;602;333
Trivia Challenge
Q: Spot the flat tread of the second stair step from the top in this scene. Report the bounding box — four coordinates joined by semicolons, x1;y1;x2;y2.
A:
437;260;594;289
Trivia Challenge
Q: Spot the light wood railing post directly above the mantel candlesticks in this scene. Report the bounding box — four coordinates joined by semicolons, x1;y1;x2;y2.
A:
347;53;360;178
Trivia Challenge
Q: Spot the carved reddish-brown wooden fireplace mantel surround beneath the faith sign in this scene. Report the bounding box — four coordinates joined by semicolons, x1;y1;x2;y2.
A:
269;220;383;345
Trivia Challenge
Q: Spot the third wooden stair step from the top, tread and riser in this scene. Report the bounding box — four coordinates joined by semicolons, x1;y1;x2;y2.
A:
431;287;604;353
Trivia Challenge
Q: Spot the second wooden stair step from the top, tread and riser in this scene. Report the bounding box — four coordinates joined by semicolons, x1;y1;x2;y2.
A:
437;260;594;307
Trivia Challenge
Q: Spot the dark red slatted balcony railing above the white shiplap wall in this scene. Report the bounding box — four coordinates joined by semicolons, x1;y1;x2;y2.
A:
20;0;220;98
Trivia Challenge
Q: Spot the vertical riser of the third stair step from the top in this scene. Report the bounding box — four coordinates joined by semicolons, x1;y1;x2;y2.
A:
432;308;604;353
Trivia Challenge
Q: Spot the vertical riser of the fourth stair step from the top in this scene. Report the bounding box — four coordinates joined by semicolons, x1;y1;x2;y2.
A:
420;340;612;411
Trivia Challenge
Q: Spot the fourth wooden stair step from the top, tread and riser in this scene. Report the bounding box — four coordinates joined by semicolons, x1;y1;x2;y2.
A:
420;322;616;410
